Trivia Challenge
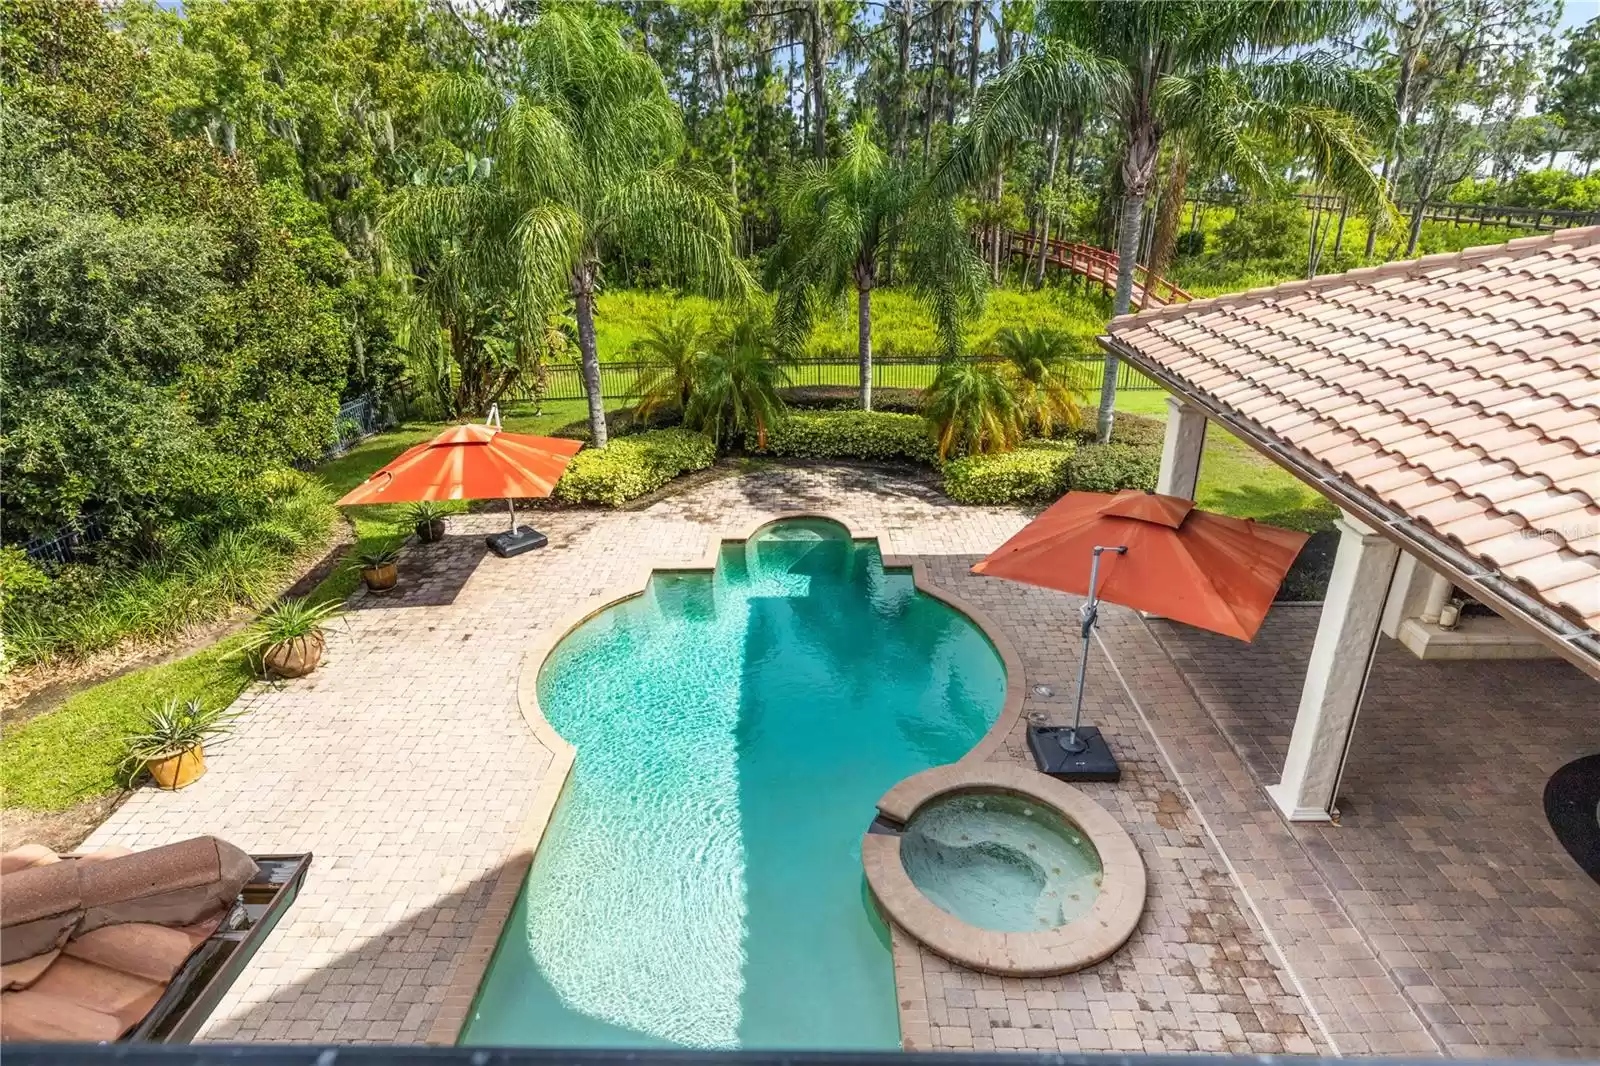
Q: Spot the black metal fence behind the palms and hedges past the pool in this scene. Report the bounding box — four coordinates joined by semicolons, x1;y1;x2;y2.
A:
506;355;1160;400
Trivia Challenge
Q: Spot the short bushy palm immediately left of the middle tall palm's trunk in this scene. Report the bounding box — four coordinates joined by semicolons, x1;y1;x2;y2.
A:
683;311;789;448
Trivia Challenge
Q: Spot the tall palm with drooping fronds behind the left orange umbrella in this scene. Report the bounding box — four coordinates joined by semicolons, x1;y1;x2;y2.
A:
389;5;752;448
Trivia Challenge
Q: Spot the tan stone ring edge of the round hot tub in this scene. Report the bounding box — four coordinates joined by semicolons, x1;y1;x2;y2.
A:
861;760;1146;976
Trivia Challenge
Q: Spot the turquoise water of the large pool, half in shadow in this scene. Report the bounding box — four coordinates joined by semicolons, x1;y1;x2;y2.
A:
462;519;1005;1048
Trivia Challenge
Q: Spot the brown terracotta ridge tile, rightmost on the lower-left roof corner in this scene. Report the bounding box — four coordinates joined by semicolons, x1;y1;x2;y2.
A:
75;837;256;935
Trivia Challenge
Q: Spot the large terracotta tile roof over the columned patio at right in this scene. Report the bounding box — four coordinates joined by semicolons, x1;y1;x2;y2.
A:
1110;227;1600;632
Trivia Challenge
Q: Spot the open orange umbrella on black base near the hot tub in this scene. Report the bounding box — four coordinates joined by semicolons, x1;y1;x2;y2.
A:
973;490;1307;779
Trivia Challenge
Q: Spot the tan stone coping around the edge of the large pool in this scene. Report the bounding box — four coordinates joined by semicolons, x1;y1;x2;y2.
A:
424;511;1024;1047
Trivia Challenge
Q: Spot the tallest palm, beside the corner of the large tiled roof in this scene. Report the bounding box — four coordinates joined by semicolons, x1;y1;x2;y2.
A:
934;0;1395;440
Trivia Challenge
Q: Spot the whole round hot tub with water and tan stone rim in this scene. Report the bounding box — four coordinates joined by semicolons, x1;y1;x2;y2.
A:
861;762;1146;975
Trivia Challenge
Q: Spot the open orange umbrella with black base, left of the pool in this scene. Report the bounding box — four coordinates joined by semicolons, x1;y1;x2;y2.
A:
339;408;584;555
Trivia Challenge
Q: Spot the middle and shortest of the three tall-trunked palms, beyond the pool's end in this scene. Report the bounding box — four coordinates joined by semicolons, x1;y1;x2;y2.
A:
771;123;987;410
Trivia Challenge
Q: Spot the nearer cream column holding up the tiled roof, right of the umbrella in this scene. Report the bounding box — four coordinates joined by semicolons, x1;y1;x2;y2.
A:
1267;514;1398;821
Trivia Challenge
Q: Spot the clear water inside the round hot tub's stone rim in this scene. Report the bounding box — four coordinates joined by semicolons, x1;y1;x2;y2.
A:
901;792;1101;933
